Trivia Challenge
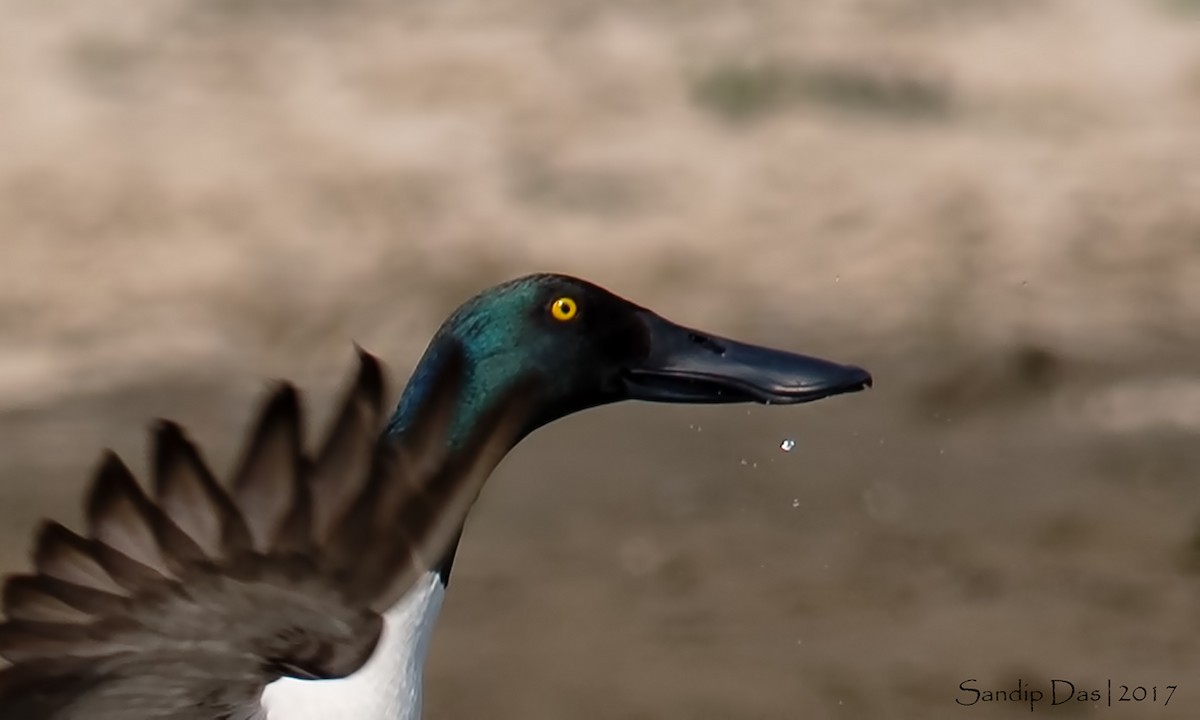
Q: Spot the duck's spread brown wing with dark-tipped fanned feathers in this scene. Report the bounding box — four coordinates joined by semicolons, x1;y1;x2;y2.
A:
0;348;529;720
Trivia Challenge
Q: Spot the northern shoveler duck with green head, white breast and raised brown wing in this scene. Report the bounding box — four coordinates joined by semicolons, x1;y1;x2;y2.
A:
0;275;871;720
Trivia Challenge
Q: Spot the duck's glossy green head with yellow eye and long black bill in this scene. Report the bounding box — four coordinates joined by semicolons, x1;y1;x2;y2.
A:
390;274;871;443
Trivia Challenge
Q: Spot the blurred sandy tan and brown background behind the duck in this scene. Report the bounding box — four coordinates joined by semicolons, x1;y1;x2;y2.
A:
0;0;1200;720
